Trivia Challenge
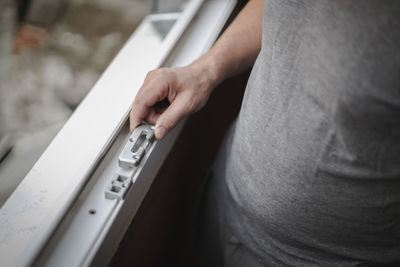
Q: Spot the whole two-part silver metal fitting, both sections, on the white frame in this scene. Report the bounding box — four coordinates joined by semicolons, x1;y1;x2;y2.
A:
105;124;154;200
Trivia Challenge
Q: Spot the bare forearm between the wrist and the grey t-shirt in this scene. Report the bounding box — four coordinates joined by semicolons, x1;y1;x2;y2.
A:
193;0;263;84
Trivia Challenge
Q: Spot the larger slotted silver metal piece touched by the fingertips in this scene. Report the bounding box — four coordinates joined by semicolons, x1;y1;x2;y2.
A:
118;124;154;168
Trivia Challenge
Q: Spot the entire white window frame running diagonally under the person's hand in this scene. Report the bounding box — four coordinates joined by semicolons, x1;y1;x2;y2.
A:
0;0;236;266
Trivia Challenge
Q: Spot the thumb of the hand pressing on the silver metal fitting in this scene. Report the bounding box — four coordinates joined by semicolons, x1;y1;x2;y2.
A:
155;96;190;139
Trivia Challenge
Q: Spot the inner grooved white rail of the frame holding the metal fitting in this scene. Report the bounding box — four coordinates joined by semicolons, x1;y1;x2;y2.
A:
35;0;236;267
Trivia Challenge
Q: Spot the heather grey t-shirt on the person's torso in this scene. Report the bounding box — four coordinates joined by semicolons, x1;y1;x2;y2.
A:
216;0;400;266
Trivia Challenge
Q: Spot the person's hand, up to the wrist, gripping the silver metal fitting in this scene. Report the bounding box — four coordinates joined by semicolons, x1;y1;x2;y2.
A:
130;63;215;139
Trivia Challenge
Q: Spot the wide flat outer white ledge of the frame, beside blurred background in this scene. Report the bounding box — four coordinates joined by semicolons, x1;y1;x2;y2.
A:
0;0;203;266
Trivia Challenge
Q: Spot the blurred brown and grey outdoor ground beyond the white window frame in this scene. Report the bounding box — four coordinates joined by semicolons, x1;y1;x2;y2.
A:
0;0;185;207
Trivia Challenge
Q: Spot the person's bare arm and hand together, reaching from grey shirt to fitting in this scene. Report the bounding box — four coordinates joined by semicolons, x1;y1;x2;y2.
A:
130;0;263;139
